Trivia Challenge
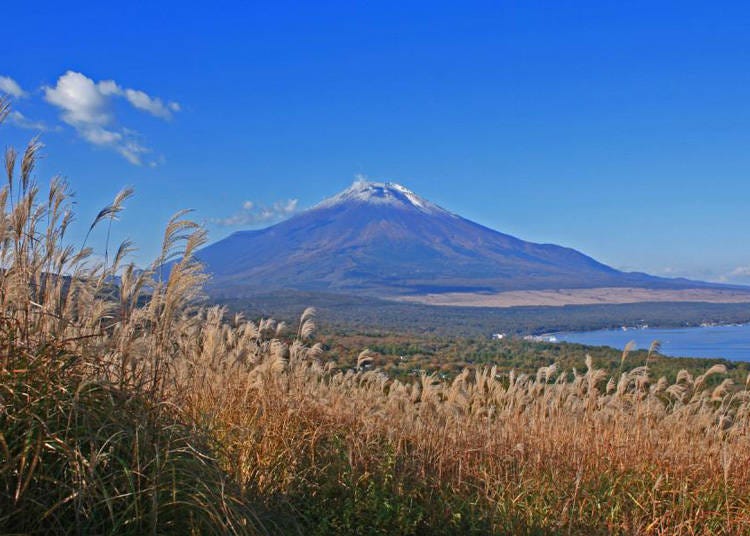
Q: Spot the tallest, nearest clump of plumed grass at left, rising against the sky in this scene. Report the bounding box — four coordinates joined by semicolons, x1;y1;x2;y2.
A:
0;101;260;534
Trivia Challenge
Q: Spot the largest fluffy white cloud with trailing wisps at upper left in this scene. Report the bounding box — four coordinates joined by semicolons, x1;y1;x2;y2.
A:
44;71;180;165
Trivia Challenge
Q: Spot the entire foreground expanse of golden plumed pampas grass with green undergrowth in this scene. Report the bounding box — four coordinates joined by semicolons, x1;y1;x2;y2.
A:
0;99;750;534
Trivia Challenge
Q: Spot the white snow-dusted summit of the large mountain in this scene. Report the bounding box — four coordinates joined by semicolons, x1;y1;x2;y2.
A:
315;179;446;213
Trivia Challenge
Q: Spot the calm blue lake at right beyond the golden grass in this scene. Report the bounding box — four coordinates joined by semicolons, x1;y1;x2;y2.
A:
554;324;750;361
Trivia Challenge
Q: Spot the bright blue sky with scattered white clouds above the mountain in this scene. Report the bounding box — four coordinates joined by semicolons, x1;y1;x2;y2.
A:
0;1;750;283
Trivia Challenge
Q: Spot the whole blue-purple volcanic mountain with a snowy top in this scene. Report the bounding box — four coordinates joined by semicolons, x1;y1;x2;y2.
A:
199;181;724;296
